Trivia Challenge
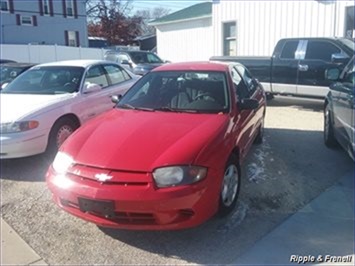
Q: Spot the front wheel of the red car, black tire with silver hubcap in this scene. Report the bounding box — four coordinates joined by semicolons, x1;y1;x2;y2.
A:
218;155;241;217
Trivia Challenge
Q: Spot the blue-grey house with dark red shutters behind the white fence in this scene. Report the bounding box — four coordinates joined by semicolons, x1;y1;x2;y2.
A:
0;0;88;47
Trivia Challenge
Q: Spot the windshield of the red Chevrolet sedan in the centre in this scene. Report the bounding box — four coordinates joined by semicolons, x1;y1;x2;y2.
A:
116;71;229;113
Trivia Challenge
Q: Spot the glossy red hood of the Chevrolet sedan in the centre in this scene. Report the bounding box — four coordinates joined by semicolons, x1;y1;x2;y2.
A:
61;109;228;172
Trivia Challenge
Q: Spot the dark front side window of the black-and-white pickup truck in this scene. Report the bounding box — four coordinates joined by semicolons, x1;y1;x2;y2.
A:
305;41;341;62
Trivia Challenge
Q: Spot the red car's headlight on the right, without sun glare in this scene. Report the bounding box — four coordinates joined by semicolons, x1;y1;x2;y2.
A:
153;166;207;187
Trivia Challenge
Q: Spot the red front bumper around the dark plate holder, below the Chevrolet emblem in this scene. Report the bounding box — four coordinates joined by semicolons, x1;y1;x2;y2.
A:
46;165;221;230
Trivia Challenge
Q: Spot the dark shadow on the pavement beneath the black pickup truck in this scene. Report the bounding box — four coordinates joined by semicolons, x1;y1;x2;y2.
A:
267;96;324;112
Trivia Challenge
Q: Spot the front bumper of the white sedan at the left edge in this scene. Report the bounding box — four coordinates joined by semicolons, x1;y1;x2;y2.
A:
0;130;48;159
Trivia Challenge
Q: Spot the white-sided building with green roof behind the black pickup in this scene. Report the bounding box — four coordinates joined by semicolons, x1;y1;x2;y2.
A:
151;0;355;62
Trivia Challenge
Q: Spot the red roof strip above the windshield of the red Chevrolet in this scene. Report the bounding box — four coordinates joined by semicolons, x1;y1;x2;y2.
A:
152;61;231;72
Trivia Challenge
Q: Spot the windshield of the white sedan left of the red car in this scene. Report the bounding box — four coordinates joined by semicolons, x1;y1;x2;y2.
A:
1;66;84;94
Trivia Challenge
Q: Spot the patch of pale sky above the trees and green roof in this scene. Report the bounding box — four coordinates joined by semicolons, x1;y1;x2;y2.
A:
132;0;207;13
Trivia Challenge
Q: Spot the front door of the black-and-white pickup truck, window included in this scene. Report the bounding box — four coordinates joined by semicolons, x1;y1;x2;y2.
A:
297;40;345;97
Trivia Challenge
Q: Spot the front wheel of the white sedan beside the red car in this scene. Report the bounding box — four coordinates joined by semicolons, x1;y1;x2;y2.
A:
46;117;78;155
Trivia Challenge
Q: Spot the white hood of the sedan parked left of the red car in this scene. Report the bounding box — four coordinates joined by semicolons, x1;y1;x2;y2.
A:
0;93;73;123
